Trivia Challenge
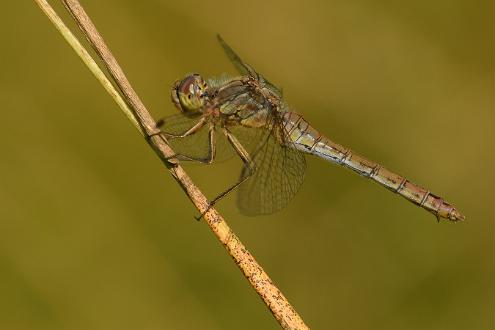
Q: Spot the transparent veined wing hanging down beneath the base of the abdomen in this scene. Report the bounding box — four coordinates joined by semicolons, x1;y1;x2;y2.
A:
233;123;306;216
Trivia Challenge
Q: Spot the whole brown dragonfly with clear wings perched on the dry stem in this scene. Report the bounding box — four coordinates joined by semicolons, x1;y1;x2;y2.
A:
157;35;465;222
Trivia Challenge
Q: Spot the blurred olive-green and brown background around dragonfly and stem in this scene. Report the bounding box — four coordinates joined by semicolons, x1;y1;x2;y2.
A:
0;0;495;329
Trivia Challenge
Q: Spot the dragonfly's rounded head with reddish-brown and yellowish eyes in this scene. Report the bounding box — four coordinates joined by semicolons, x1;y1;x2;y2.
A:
172;73;208;112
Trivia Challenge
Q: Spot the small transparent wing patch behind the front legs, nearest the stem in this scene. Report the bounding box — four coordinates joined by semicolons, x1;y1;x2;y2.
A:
161;113;234;161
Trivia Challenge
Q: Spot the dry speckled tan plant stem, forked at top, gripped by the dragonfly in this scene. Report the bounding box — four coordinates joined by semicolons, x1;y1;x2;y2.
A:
34;0;308;329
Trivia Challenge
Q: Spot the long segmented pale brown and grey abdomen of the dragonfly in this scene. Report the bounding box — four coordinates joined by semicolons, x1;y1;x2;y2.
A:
283;112;464;221
